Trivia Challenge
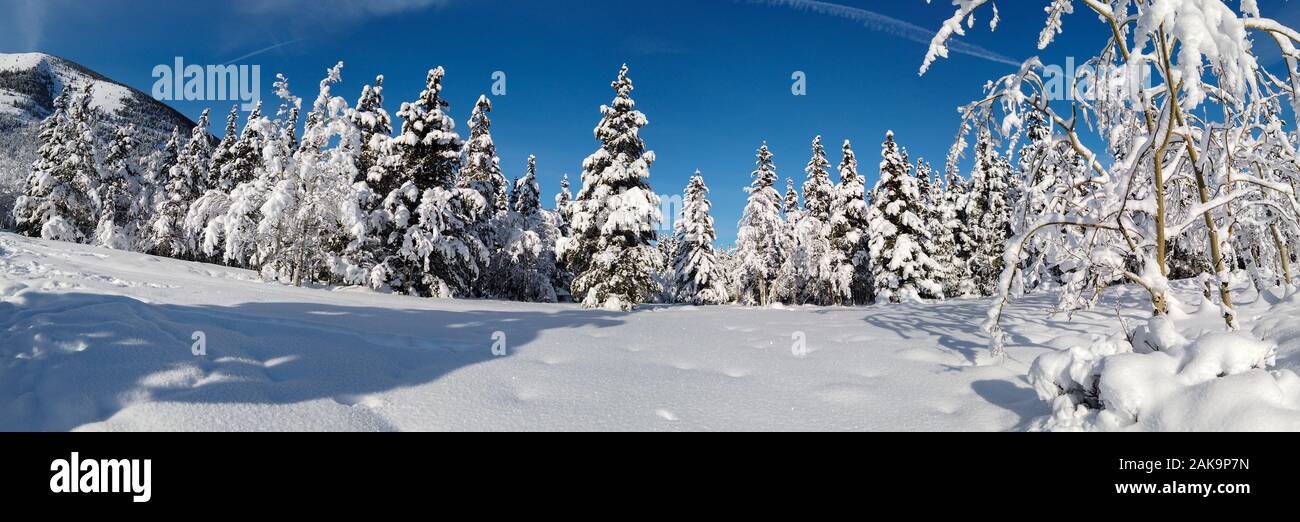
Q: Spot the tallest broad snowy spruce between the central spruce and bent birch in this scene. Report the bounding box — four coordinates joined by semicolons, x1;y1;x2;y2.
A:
867;131;943;303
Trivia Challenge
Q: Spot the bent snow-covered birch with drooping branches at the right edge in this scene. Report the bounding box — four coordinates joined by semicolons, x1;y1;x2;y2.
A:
923;0;1300;356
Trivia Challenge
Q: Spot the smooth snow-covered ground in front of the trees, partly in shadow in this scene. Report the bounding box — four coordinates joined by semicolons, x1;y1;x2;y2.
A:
0;229;1300;430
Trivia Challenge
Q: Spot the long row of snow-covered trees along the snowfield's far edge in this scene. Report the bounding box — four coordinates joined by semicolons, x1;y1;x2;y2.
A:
14;64;1279;309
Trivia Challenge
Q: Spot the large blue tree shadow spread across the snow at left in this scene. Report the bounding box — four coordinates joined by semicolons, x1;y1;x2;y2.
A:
0;291;623;431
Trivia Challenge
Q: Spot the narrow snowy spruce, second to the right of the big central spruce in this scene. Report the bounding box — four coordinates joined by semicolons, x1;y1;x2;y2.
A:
736;143;785;306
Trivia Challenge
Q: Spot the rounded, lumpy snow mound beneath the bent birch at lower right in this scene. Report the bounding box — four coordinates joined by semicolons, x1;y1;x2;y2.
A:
1030;306;1300;431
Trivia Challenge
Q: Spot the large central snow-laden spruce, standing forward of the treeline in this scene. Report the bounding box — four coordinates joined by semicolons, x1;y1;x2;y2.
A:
558;65;663;310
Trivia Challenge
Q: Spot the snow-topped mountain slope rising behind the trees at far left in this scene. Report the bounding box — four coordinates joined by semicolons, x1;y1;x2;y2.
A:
0;53;194;225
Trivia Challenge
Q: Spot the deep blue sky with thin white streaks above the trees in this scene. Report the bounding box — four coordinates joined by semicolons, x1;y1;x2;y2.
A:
0;0;1300;244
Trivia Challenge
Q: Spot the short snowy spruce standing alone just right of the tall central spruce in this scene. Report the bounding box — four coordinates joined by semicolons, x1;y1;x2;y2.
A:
672;170;728;305
